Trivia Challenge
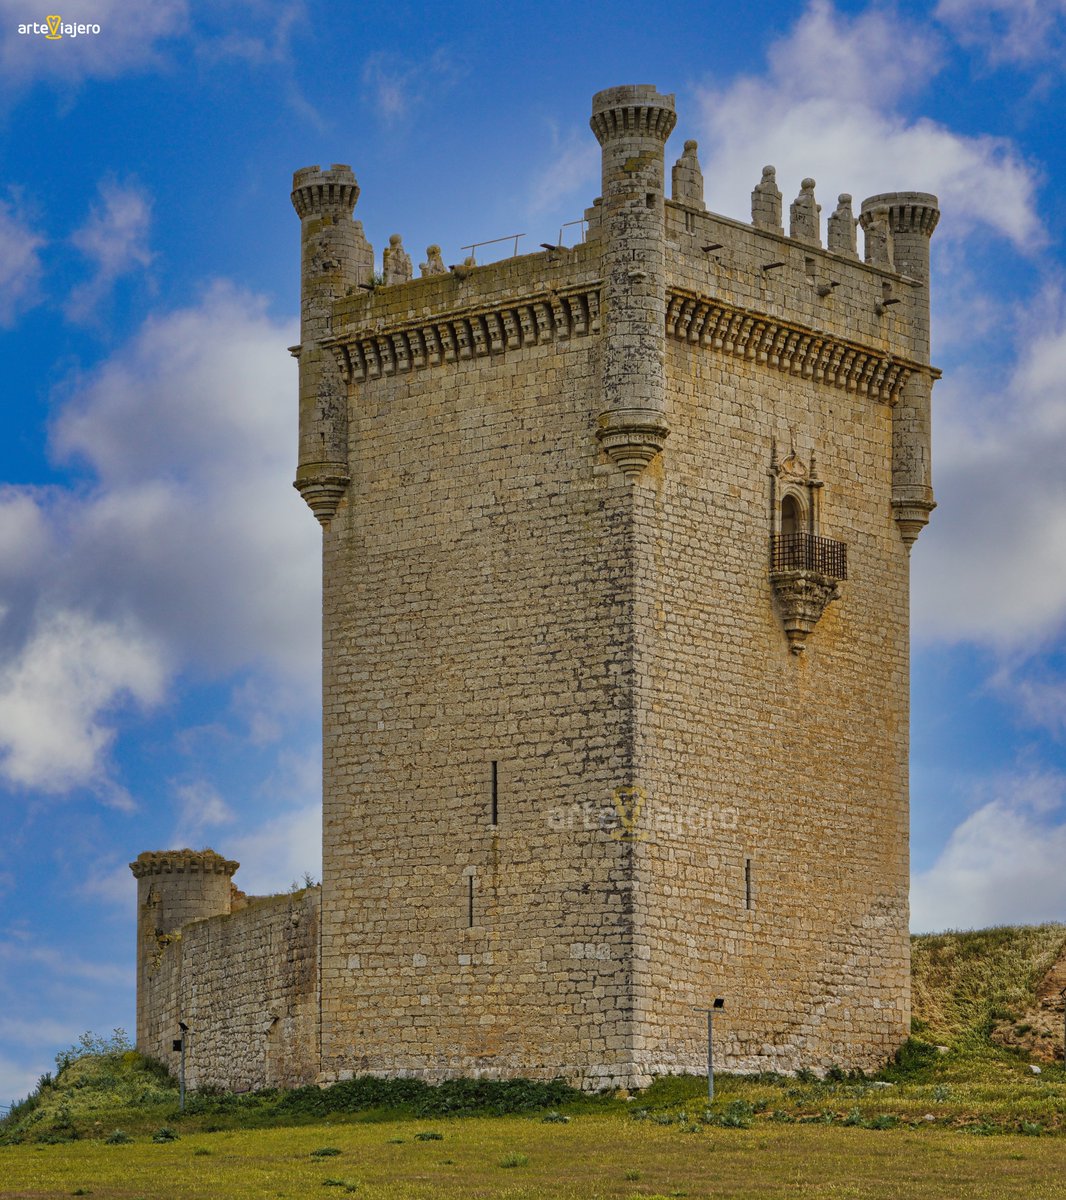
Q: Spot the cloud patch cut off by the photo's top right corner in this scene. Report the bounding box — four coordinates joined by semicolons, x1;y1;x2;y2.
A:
935;0;1066;66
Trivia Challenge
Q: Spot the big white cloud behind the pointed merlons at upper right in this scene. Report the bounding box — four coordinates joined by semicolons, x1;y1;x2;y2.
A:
682;0;1043;248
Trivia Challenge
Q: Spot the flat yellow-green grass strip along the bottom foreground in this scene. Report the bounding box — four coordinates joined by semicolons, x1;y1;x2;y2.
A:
0;1115;1066;1200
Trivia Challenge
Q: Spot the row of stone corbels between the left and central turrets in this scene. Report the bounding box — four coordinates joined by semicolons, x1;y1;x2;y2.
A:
325;282;600;383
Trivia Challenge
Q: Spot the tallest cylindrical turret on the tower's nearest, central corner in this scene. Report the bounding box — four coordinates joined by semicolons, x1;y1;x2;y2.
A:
589;84;677;479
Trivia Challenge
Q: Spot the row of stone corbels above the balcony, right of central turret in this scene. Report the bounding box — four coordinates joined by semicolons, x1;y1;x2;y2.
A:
666;288;940;404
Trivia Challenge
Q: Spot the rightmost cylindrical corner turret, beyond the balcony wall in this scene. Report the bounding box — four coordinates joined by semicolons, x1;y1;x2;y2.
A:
860;192;940;548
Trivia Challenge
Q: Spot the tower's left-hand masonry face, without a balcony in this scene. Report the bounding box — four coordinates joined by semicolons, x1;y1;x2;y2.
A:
323;246;653;1082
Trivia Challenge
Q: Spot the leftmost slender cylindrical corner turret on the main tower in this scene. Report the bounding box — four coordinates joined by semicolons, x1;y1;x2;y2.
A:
292;163;373;526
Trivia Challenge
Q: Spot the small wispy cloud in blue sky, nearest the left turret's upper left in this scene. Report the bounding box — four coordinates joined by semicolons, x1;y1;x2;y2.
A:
64;179;152;322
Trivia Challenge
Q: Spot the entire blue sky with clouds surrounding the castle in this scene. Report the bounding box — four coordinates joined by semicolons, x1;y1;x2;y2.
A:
0;0;1066;1103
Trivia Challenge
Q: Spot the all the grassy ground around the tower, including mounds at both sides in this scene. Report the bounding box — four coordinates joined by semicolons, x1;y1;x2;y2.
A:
0;926;1066;1200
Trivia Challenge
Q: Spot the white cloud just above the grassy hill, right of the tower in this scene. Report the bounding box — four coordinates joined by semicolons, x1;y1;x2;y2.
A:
911;774;1066;932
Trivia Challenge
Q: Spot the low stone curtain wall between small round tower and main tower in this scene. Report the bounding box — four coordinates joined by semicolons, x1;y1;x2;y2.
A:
139;888;321;1092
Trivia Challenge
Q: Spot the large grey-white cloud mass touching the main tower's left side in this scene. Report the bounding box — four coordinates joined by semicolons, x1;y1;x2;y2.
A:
0;284;319;796
